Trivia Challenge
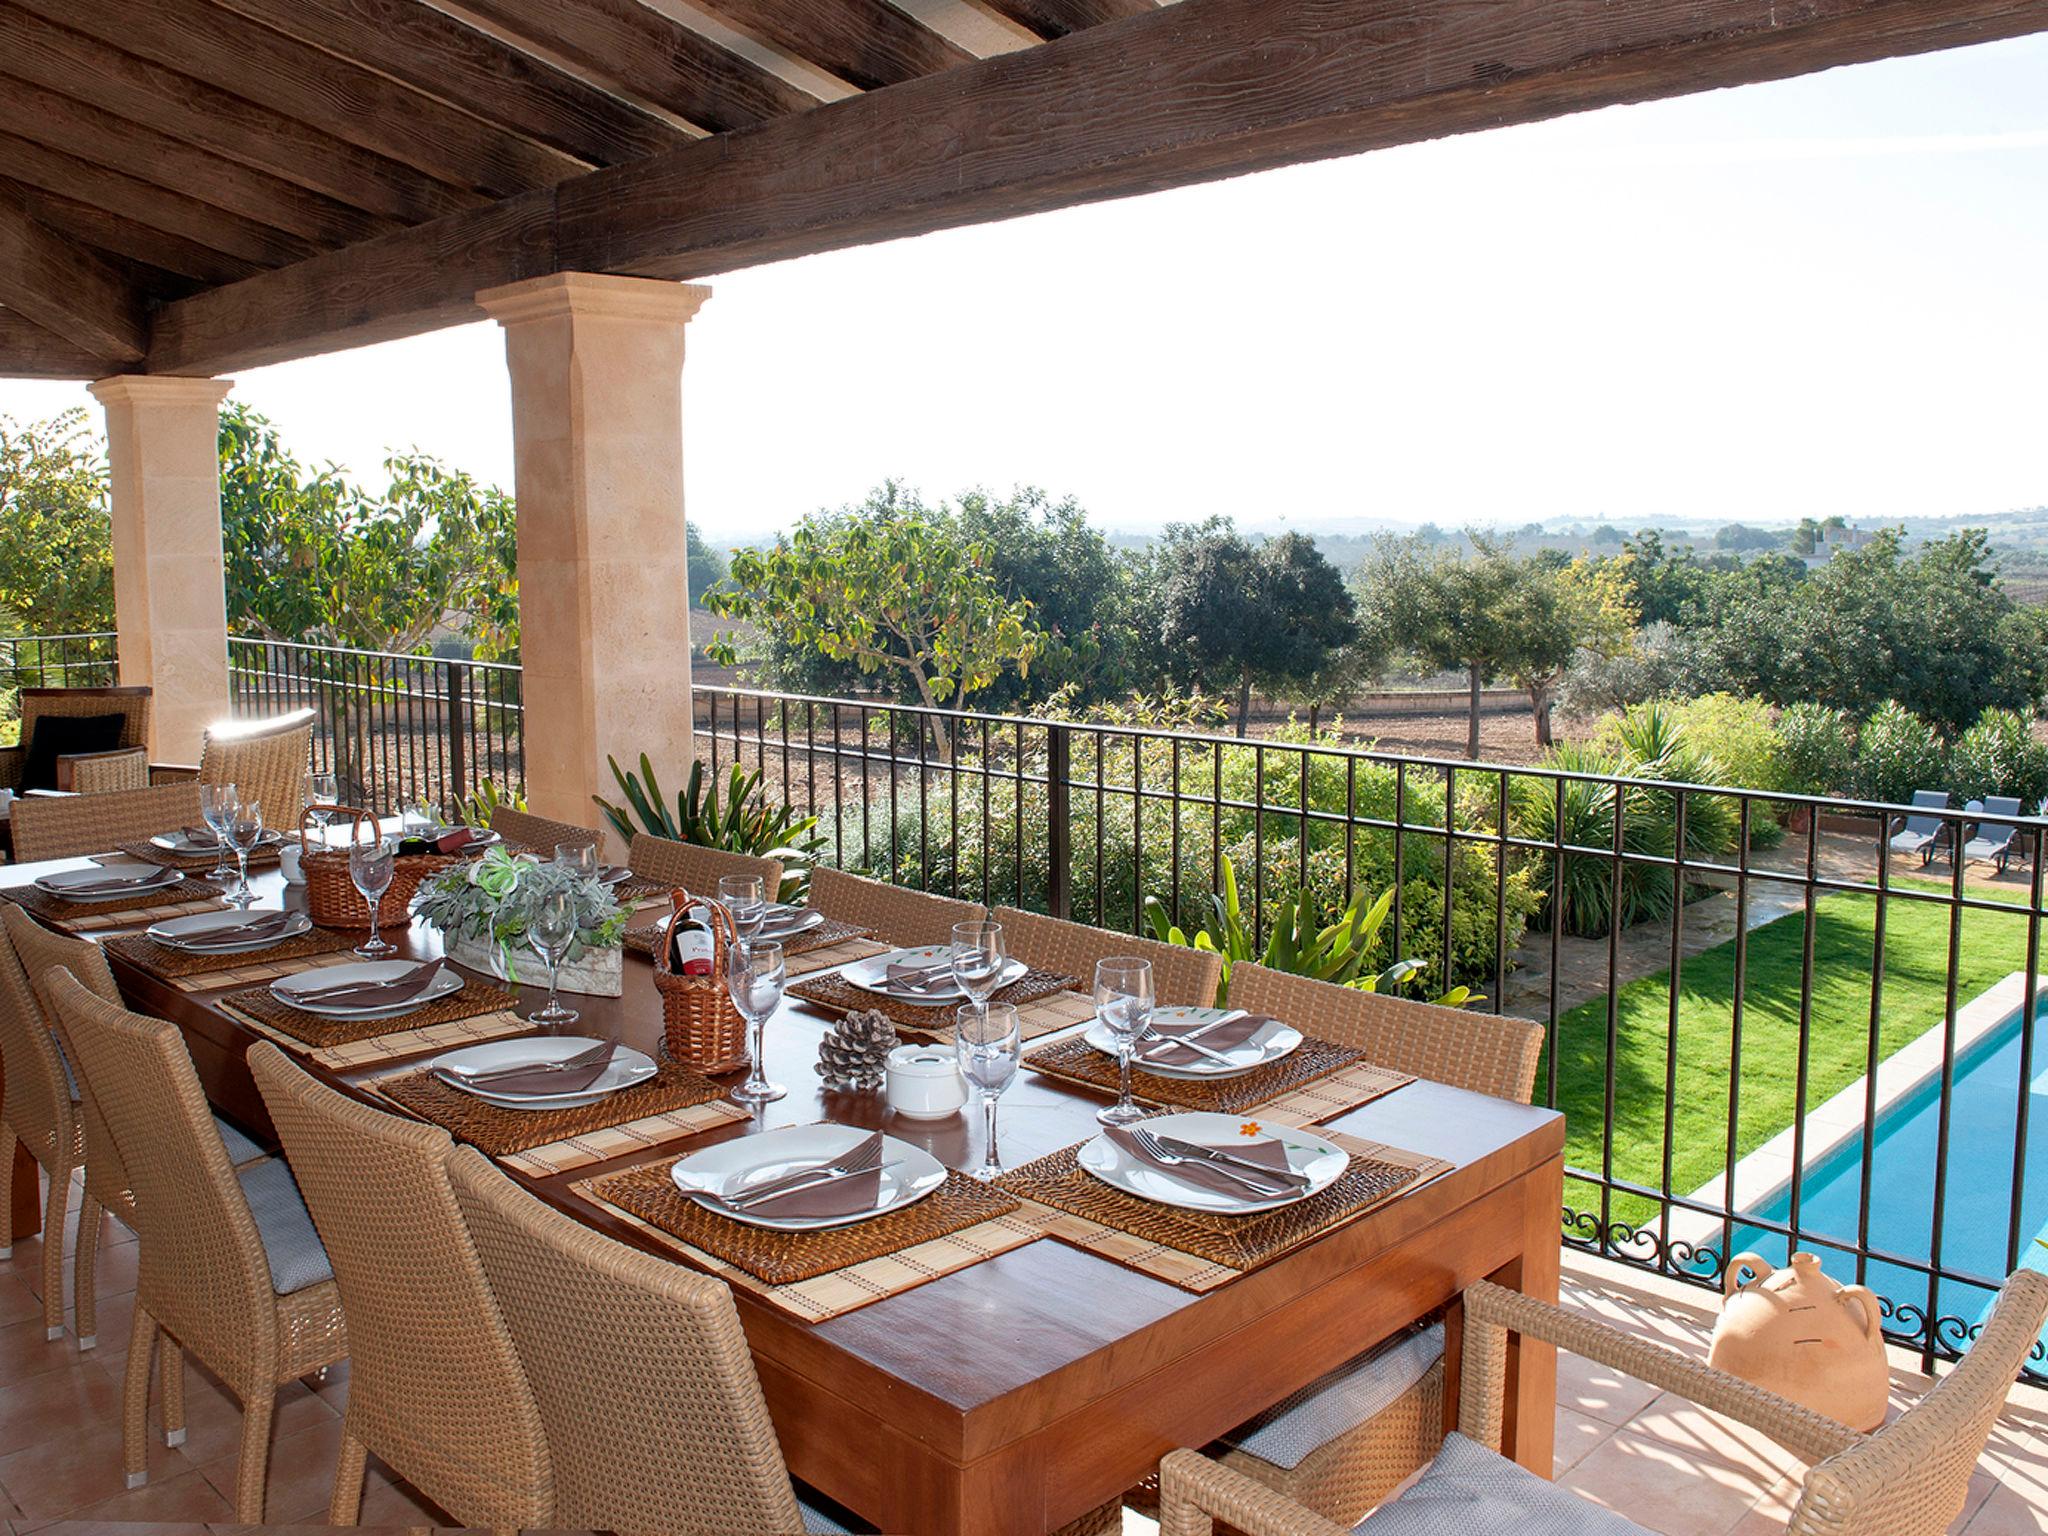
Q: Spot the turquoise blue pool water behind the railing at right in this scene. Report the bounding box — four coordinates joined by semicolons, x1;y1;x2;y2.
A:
1733;1008;2048;1337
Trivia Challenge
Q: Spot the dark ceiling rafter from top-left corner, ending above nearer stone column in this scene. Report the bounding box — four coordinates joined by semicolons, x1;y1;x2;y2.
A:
14;0;588;197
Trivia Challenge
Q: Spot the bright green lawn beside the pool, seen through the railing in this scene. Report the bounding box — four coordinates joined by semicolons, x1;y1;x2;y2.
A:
1536;881;2025;1223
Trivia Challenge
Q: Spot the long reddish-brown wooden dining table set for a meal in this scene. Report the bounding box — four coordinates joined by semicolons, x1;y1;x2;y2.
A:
0;860;1565;1536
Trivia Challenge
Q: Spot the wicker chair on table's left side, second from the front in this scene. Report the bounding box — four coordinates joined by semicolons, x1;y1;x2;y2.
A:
248;1040;552;1530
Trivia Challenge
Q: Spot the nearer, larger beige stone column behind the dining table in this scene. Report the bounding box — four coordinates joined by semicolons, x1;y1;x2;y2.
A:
477;272;711;831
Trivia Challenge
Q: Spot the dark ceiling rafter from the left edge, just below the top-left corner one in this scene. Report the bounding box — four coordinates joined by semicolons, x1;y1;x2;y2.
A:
0;72;399;250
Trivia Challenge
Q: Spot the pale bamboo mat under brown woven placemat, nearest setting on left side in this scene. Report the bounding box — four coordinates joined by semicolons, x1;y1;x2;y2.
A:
569;1157;1044;1323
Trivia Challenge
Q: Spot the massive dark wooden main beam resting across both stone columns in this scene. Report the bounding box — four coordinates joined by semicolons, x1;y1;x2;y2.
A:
150;0;2048;373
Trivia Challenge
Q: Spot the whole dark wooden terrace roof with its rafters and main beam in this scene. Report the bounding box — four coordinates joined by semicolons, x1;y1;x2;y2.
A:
0;0;2048;377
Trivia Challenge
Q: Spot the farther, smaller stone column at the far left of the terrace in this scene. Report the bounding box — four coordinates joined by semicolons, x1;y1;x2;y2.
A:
92;373;231;764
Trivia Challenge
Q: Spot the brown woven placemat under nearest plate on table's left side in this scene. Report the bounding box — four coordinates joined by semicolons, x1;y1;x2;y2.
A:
590;1157;1020;1286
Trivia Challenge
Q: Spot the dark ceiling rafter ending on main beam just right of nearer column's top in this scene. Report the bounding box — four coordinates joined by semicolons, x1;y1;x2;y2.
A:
463;0;817;133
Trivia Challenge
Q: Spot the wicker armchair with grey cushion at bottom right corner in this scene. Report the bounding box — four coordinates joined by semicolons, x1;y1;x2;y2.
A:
1159;1270;2048;1536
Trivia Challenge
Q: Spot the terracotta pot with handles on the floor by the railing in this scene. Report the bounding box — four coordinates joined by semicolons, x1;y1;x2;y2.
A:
1708;1253;1890;1430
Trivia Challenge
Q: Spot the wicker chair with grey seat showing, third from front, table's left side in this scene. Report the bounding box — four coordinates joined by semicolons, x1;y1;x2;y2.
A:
47;971;348;1526
